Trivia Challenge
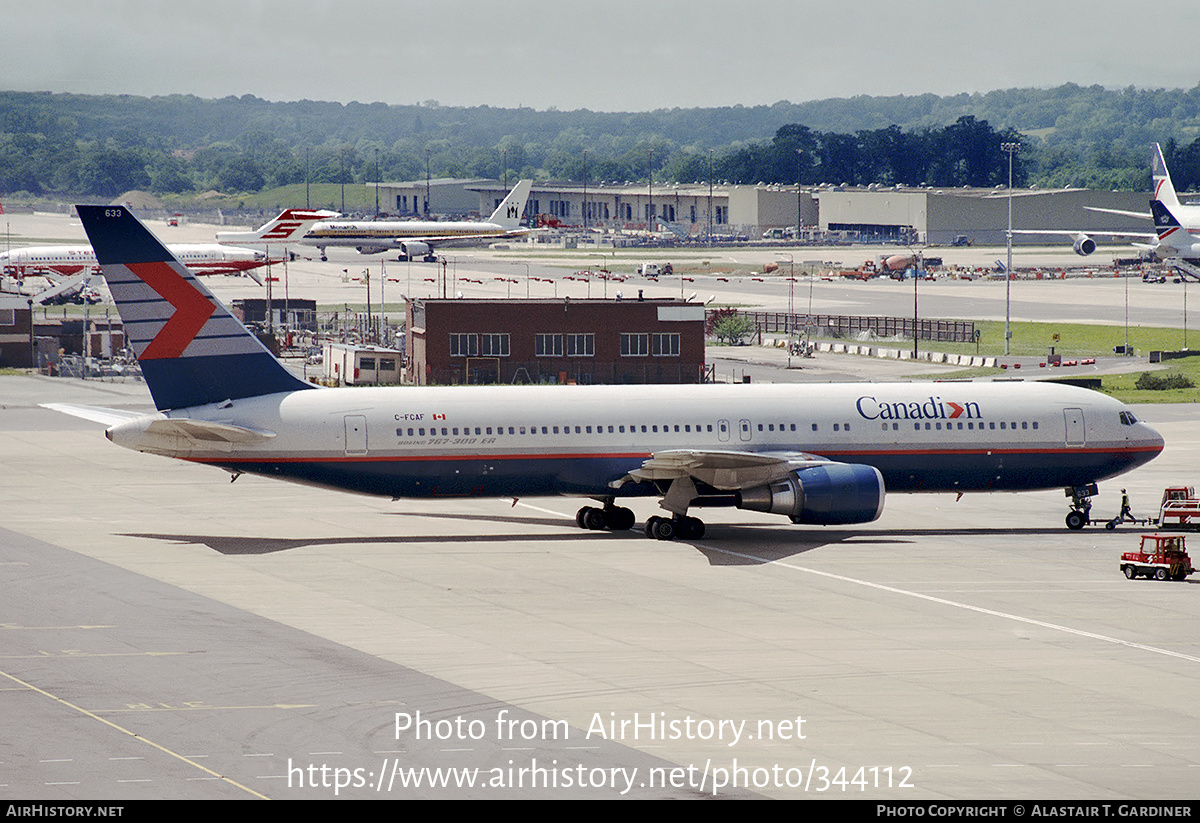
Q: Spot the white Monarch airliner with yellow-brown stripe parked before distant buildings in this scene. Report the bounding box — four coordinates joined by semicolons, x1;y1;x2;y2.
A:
304;180;533;263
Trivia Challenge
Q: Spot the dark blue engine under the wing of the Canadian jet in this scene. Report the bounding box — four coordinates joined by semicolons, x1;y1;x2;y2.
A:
738;463;884;525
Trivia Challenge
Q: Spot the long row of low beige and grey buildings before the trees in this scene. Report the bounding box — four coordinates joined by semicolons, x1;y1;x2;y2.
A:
378;178;1152;245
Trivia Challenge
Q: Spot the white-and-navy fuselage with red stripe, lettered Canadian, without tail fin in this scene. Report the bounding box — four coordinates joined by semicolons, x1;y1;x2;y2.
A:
110;383;1163;498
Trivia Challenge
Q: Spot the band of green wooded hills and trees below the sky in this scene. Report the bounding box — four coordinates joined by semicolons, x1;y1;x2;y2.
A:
0;84;1200;197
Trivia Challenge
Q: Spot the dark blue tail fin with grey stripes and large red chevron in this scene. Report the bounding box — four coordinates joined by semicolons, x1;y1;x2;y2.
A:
76;205;314;410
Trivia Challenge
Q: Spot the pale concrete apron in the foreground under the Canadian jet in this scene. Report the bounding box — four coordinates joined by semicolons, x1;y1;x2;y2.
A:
0;209;1200;801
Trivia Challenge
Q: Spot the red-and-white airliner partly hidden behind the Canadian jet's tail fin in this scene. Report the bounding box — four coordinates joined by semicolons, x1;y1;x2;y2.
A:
0;209;337;280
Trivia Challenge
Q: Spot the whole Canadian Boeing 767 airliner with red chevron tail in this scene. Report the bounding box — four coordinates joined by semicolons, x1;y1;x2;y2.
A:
54;206;1163;540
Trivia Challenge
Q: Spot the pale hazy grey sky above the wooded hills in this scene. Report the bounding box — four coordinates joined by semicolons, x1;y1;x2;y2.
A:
9;0;1200;112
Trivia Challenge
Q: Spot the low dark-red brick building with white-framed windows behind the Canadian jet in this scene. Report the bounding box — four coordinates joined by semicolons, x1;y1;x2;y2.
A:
406;299;704;385
